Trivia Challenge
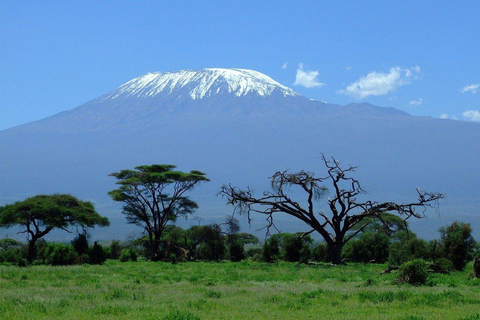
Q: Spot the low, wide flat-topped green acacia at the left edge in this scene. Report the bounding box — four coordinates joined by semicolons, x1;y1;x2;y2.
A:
0;194;110;263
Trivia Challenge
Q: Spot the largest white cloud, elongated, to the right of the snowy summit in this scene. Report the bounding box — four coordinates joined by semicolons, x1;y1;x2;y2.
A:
337;66;420;99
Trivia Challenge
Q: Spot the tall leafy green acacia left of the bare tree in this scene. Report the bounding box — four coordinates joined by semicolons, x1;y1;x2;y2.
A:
108;164;209;260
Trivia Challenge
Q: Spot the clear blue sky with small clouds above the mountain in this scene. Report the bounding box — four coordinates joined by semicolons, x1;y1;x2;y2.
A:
0;1;480;130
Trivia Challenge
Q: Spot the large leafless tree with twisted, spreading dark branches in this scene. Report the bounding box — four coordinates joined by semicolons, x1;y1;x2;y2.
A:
219;155;444;264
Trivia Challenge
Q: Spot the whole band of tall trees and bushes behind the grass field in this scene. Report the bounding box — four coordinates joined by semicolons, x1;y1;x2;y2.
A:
0;156;478;272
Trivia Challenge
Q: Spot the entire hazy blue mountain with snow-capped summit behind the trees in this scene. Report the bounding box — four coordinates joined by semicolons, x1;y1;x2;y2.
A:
0;69;480;239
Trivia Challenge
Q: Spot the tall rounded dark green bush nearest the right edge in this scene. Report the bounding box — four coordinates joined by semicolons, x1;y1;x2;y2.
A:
440;221;475;270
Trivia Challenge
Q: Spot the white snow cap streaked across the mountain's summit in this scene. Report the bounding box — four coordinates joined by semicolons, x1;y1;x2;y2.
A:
103;68;299;100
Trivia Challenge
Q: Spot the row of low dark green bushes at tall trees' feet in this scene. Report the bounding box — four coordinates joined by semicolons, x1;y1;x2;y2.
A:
0;220;480;273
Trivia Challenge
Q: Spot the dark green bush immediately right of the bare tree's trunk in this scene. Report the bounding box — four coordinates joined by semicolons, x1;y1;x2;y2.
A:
343;231;390;263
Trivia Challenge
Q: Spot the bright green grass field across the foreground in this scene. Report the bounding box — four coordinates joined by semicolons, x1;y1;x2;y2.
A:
0;261;480;320
